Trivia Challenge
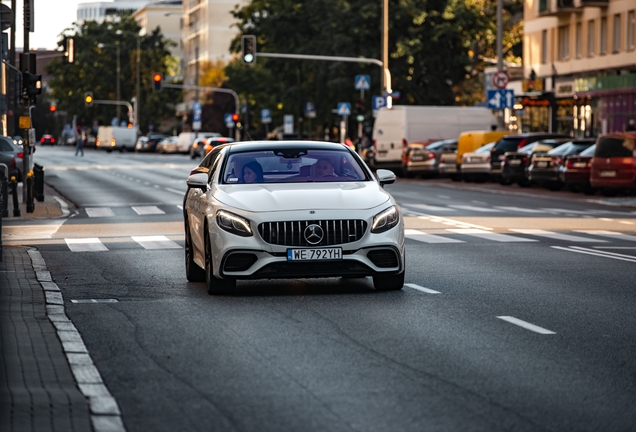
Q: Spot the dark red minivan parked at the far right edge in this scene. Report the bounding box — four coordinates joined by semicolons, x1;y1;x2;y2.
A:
590;133;636;195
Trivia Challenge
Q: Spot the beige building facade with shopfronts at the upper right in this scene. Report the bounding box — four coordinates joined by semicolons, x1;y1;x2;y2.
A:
518;0;636;137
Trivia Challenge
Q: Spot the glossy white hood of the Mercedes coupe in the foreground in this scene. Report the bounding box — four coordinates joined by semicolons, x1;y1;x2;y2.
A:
214;182;391;212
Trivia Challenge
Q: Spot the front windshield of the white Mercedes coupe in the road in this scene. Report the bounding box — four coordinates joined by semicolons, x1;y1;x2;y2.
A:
220;149;369;184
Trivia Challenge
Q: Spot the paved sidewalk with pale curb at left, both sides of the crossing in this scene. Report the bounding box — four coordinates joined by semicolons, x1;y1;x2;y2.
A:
0;185;125;432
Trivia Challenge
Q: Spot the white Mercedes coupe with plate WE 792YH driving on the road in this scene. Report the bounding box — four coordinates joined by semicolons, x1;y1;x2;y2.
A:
183;141;405;294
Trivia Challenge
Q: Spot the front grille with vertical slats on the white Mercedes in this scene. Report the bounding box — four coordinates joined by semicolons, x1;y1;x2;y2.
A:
258;219;367;247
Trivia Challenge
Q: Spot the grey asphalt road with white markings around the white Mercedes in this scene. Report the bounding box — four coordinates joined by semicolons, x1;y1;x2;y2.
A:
4;148;636;431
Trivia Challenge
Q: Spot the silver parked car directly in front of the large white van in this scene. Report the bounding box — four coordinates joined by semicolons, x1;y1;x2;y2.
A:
402;139;457;177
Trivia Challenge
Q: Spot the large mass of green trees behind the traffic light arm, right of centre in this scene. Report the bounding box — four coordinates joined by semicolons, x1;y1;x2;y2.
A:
226;0;523;135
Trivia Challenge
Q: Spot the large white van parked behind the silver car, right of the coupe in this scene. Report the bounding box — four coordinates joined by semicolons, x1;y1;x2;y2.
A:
369;105;497;170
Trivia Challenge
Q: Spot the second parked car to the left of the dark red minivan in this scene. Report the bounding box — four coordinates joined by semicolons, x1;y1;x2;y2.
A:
528;139;595;190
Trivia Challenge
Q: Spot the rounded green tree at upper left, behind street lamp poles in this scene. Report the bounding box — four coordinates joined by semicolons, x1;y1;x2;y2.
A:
47;15;181;131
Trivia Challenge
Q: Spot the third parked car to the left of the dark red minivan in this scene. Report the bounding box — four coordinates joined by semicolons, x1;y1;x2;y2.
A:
499;138;567;187
